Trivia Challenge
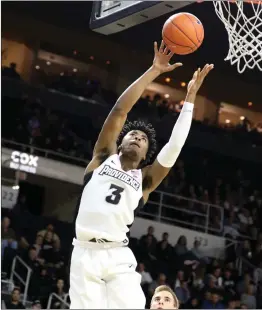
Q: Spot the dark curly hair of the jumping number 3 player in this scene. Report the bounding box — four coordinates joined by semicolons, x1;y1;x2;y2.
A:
117;120;157;168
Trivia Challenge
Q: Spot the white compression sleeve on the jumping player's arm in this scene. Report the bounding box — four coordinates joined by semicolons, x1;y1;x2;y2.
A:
157;102;194;168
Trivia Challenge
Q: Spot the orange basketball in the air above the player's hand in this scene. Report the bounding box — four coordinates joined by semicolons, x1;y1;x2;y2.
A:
162;13;204;55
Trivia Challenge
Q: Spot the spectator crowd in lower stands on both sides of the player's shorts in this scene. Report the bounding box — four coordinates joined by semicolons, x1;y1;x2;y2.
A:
2;212;262;309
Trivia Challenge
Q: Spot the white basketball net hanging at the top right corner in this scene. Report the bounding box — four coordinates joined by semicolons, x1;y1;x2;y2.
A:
213;0;262;73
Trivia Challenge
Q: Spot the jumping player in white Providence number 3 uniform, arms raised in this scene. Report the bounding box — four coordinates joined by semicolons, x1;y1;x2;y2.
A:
70;42;213;309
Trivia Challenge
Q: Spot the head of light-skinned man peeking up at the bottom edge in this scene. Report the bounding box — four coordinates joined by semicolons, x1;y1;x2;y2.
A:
150;285;179;309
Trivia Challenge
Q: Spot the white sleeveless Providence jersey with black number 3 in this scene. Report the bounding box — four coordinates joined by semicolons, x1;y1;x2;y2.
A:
76;154;143;243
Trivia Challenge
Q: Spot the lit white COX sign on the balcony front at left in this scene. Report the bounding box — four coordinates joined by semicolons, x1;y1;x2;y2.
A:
10;151;38;173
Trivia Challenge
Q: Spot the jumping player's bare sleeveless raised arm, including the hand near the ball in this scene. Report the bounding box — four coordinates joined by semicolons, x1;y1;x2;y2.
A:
86;42;182;172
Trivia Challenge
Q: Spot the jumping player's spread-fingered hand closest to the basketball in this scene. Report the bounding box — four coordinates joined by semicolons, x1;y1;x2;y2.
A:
153;41;183;73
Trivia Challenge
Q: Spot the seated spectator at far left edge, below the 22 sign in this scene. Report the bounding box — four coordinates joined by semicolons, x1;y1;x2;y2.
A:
1;217;18;258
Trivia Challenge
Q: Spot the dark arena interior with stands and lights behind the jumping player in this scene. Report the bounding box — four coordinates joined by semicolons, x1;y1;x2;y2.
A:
1;1;262;309
